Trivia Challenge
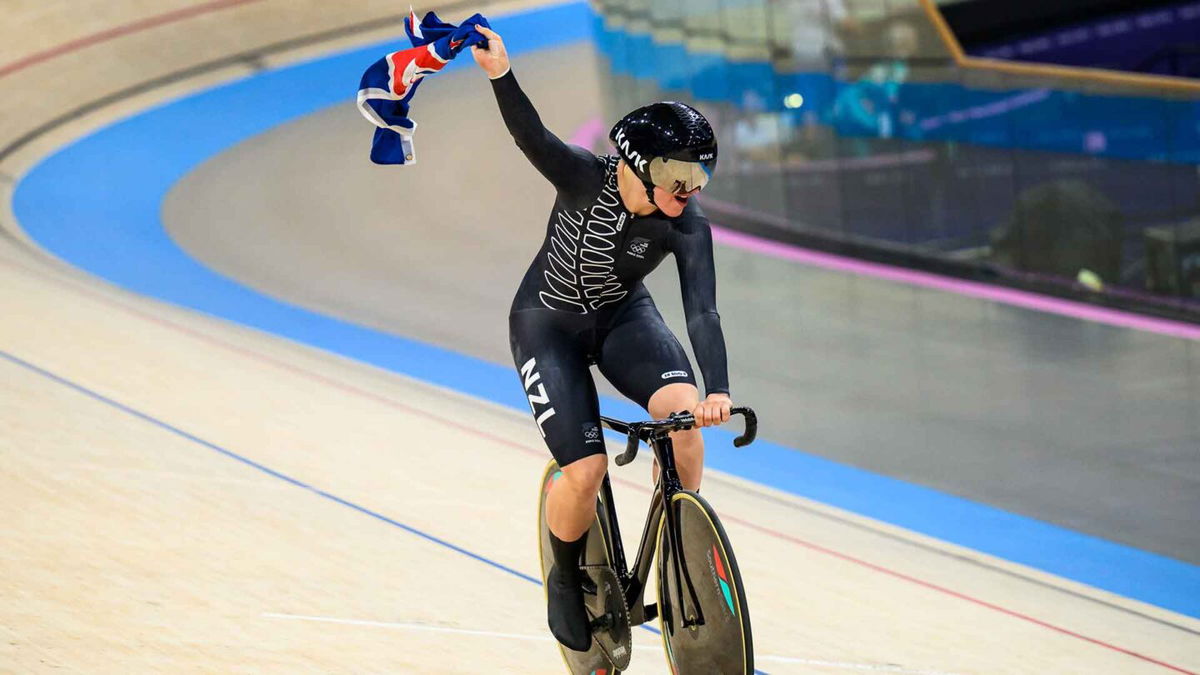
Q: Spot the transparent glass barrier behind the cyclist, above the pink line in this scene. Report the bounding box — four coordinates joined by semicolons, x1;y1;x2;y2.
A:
595;0;1200;319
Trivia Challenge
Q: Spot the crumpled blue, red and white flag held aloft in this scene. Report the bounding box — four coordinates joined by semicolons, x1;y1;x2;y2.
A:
359;11;491;165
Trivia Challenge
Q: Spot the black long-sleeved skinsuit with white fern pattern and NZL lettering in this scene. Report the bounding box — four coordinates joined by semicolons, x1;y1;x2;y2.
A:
492;71;730;466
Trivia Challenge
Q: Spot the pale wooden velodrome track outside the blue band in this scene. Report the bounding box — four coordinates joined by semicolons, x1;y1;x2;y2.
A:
0;0;1200;674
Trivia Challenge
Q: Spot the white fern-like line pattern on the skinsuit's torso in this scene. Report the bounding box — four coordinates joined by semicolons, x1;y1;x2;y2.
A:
539;157;629;313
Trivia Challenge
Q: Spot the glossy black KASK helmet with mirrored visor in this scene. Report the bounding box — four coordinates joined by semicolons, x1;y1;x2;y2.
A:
608;101;716;194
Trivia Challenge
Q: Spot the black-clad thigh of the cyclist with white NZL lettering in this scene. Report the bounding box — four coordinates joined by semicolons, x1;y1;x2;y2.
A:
509;309;605;466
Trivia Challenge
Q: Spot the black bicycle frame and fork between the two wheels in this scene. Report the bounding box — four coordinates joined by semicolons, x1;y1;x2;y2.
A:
600;417;704;627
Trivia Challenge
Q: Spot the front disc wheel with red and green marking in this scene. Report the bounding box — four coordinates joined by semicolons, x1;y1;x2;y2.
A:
658;491;754;675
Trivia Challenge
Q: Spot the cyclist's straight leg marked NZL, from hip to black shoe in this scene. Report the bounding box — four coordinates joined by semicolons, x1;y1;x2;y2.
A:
509;310;607;651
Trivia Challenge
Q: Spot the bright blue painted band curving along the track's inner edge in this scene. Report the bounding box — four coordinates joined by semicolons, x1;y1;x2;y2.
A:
13;4;1200;617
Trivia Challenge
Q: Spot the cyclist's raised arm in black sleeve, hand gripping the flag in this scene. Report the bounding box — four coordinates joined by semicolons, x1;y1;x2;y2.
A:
472;26;604;199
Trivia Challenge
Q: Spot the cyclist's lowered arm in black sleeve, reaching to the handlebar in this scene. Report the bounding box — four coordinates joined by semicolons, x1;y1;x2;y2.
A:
672;202;730;396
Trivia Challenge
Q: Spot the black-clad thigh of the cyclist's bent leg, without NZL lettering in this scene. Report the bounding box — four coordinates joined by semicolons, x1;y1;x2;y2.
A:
600;295;696;408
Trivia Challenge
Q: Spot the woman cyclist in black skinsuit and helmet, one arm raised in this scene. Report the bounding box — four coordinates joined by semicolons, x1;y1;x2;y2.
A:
472;26;732;651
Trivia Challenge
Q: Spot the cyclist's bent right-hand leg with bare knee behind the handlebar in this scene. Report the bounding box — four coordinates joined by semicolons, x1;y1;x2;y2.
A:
599;295;704;490
